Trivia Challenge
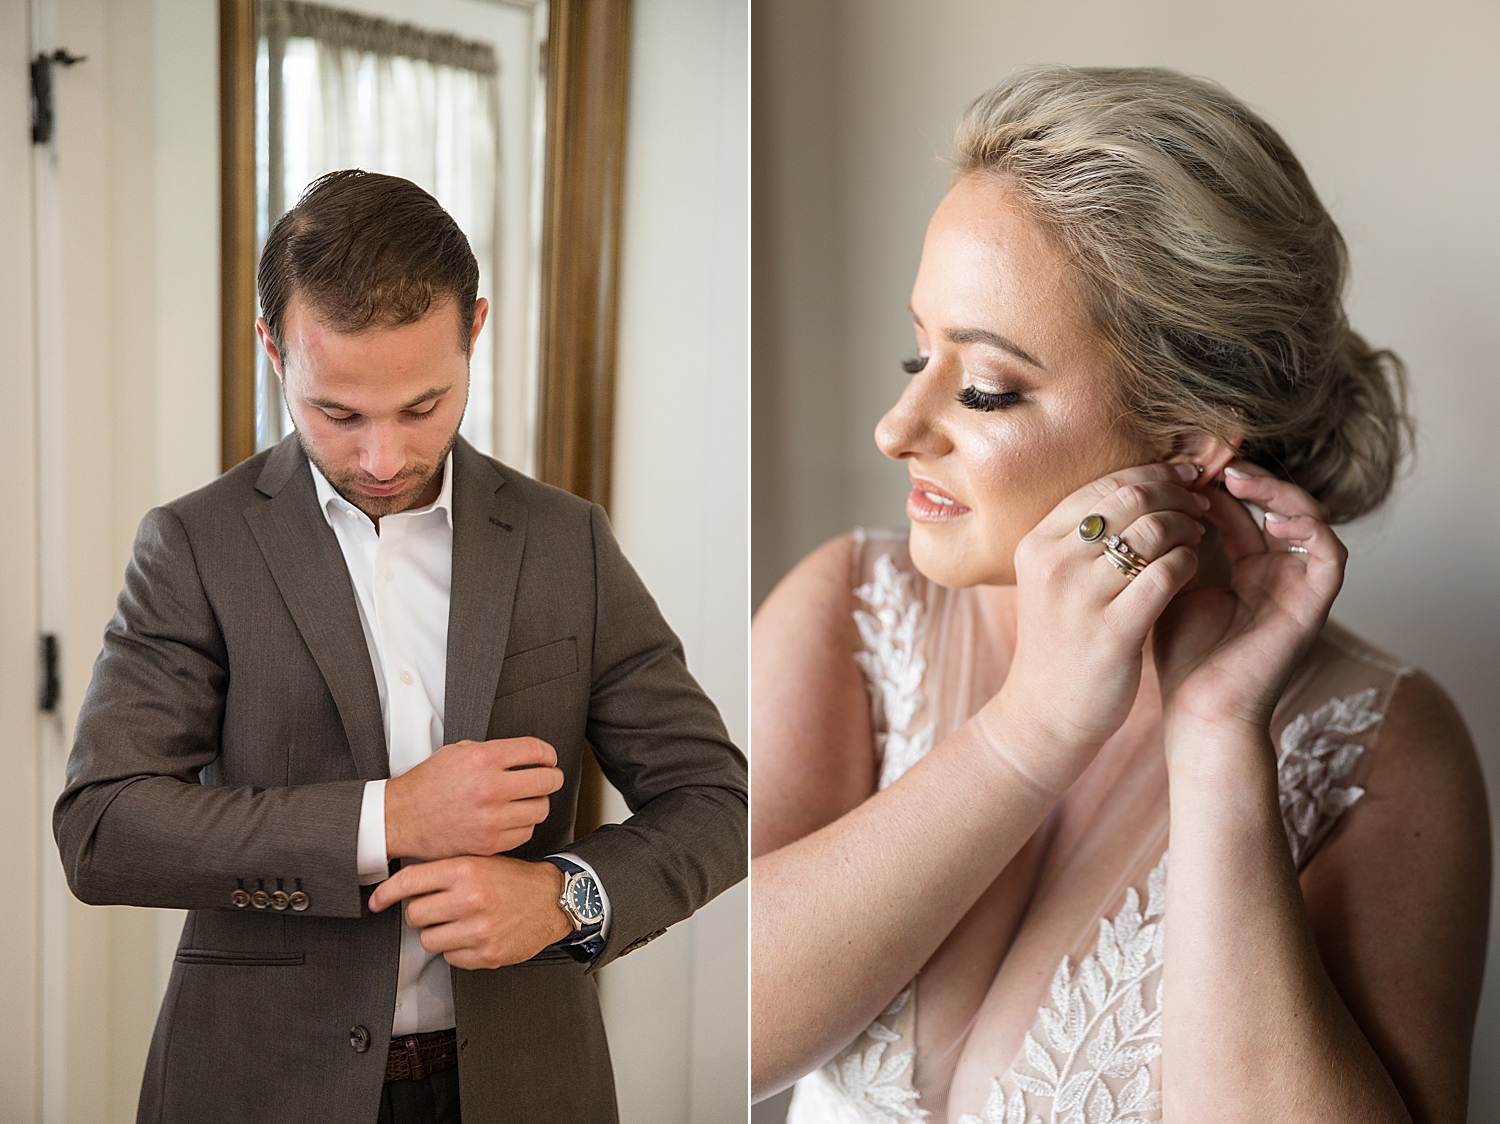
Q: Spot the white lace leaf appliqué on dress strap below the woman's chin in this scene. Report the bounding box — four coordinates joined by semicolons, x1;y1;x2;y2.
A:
854;554;933;788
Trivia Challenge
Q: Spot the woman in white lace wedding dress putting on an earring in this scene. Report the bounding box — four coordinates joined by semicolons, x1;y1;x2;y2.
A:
753;68;1490;1124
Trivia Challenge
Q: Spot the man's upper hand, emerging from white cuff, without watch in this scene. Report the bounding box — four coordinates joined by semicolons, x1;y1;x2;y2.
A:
386;738;563;870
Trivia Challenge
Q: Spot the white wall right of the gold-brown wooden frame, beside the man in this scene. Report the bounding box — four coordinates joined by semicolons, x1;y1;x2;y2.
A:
600;0;749;1124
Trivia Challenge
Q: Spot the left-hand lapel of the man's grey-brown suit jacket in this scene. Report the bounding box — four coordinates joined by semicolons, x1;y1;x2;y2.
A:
245;434;390;780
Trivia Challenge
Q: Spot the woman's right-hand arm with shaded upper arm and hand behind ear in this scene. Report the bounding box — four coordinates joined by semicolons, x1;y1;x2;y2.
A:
1157;462;1490;1124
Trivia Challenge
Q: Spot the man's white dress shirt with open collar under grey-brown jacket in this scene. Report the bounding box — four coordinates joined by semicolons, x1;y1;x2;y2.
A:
309;453;609;1037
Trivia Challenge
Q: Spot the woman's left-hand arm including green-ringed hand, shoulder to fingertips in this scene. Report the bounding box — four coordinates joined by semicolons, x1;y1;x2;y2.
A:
752;465;1202;1097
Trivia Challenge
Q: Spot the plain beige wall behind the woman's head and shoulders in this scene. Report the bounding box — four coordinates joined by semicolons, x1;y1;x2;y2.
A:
752;0;1500;1121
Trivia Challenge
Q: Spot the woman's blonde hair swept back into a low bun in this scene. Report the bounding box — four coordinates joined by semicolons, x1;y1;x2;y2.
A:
954;66;1412;522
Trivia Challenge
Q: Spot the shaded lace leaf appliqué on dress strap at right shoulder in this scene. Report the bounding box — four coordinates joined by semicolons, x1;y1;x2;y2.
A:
1277;687;1383;870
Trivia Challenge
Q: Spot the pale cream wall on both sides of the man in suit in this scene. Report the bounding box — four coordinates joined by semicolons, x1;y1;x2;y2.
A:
0;0;749;1124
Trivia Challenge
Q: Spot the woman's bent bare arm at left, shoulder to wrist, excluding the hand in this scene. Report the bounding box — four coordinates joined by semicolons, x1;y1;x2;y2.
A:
750;539;1055;1097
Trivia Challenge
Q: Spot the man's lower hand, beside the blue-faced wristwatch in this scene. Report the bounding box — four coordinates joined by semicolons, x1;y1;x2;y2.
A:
371;852;573;968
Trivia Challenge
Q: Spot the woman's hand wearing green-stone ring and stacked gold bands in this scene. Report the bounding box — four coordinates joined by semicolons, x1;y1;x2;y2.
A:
977;464;1209;795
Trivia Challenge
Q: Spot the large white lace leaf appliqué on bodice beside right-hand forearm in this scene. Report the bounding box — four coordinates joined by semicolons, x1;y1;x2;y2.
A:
960;854;1167;1124
